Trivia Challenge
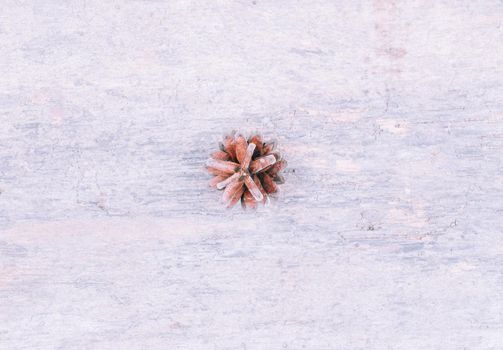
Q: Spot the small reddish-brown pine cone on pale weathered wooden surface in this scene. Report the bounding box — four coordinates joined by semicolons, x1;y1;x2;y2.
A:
206;133;286;209
